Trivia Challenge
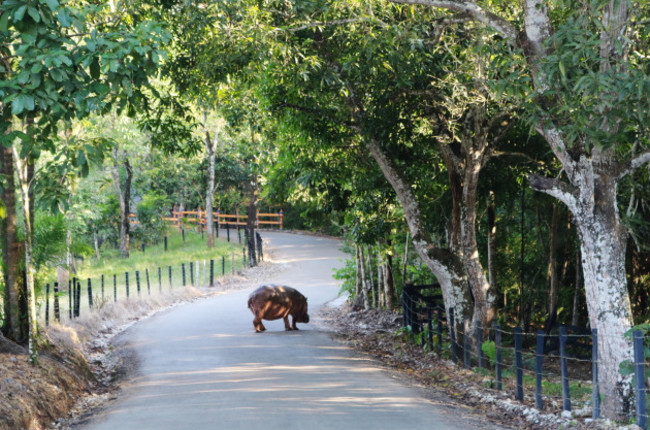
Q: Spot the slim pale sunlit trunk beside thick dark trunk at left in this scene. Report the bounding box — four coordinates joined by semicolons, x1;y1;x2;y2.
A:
12;146;38;365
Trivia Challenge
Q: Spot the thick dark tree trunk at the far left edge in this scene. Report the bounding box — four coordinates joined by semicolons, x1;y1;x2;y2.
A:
0;145;29;344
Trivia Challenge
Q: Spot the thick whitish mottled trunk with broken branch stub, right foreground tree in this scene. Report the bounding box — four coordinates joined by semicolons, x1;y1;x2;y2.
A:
529;164;633;417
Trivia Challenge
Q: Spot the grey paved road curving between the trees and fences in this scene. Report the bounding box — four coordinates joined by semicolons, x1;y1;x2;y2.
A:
83;233;506;430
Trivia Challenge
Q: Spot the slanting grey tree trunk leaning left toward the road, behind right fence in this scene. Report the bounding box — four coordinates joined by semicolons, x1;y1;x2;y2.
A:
368;139;472;327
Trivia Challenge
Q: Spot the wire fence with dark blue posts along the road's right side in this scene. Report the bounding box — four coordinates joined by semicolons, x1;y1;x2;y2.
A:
402;284;650;429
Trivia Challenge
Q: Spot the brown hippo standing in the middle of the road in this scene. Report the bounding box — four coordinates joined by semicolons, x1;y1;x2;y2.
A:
248;285;309;333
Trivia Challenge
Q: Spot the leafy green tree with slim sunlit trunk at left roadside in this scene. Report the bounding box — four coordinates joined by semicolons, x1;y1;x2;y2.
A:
0;0;166;364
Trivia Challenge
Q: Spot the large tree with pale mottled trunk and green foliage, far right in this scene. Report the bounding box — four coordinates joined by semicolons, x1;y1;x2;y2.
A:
393;0;650;418
